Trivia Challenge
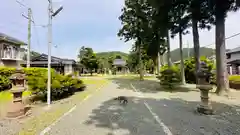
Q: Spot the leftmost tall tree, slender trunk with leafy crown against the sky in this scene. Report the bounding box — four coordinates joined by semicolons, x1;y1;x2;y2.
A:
118;0;149;80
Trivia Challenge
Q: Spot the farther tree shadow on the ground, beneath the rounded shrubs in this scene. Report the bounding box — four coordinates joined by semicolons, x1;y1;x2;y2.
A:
108;77;197;93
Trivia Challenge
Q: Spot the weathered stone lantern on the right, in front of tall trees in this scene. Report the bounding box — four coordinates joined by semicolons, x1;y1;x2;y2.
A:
197;62;213;115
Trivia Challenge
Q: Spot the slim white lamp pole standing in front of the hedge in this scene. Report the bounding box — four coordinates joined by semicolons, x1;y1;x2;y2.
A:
47;0;52;105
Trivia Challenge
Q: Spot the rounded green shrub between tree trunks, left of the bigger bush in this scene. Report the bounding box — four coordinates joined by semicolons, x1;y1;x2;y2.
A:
157;65;181;89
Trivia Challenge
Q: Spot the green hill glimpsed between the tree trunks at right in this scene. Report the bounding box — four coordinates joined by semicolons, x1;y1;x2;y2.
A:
171;47;214;62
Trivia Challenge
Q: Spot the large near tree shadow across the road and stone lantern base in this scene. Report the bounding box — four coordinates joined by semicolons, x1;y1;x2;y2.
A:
84;97;240;135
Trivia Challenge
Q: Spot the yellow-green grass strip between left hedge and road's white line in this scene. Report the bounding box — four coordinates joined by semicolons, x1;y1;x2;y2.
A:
17;78;108;135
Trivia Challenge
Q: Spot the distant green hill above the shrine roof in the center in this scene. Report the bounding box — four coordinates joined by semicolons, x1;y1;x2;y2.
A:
96;51;128;60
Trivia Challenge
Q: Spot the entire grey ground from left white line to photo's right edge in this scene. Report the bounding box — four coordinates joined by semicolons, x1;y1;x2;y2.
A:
42;77;240;135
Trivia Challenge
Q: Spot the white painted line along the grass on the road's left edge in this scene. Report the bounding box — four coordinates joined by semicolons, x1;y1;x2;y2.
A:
39;86;103;135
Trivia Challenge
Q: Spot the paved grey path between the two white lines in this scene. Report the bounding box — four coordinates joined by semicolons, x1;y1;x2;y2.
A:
46;83;168;135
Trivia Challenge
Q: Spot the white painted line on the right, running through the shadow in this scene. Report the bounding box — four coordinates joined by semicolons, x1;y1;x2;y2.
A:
131;84;173;135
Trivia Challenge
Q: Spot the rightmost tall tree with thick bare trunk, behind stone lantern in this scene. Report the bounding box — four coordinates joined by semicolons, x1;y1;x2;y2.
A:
208;0;239;94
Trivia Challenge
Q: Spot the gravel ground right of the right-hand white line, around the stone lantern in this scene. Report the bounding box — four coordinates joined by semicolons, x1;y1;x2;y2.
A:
128;78;240;135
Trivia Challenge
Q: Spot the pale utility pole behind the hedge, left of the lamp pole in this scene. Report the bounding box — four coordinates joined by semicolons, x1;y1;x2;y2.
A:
27;8;32;68
